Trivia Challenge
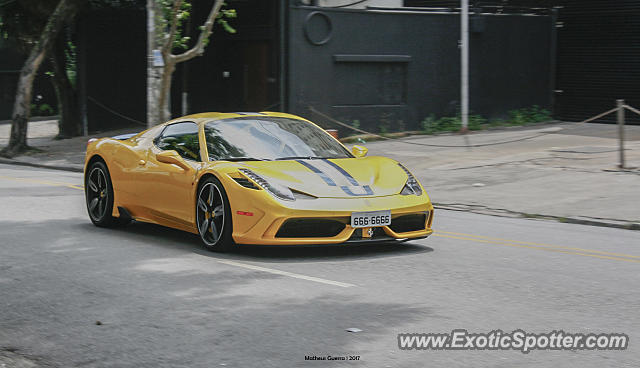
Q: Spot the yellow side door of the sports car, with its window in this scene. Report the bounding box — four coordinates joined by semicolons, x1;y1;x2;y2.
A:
139;121;201;228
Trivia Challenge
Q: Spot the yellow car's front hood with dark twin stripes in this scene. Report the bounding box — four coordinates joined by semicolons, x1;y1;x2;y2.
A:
239;156;407;198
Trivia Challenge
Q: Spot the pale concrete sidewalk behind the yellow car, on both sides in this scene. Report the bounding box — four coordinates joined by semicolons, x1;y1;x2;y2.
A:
0;121;640;229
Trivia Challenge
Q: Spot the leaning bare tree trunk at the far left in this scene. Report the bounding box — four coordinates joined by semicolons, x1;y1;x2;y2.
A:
0;0;77;157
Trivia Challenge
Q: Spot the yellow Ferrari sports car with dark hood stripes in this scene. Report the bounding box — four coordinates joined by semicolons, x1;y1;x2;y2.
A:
84;112;433;251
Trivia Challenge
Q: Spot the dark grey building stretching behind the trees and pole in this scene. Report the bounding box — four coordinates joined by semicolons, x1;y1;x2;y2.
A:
0;0;640;130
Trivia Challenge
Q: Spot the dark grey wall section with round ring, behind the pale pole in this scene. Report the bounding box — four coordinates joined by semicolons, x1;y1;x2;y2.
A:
288;7;553;134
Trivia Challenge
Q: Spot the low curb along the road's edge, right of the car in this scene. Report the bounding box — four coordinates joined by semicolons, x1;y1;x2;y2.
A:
433;203;640;231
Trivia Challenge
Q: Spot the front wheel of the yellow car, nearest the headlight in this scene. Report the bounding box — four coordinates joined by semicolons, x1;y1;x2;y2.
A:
196;177;235;252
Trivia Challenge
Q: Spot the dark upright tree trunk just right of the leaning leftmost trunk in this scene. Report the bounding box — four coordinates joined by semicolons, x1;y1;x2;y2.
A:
51;34;82;138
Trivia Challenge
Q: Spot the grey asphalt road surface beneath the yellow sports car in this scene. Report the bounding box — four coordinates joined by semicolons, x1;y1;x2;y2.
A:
0;165;640;368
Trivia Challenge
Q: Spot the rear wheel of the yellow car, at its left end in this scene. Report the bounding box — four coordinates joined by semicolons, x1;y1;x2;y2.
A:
84;161;117;227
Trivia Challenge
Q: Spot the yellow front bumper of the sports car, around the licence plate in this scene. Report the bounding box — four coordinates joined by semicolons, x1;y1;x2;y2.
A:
232;195;433;245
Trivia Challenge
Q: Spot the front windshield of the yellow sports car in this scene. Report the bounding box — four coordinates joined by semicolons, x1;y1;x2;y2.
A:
204;116;353;161
